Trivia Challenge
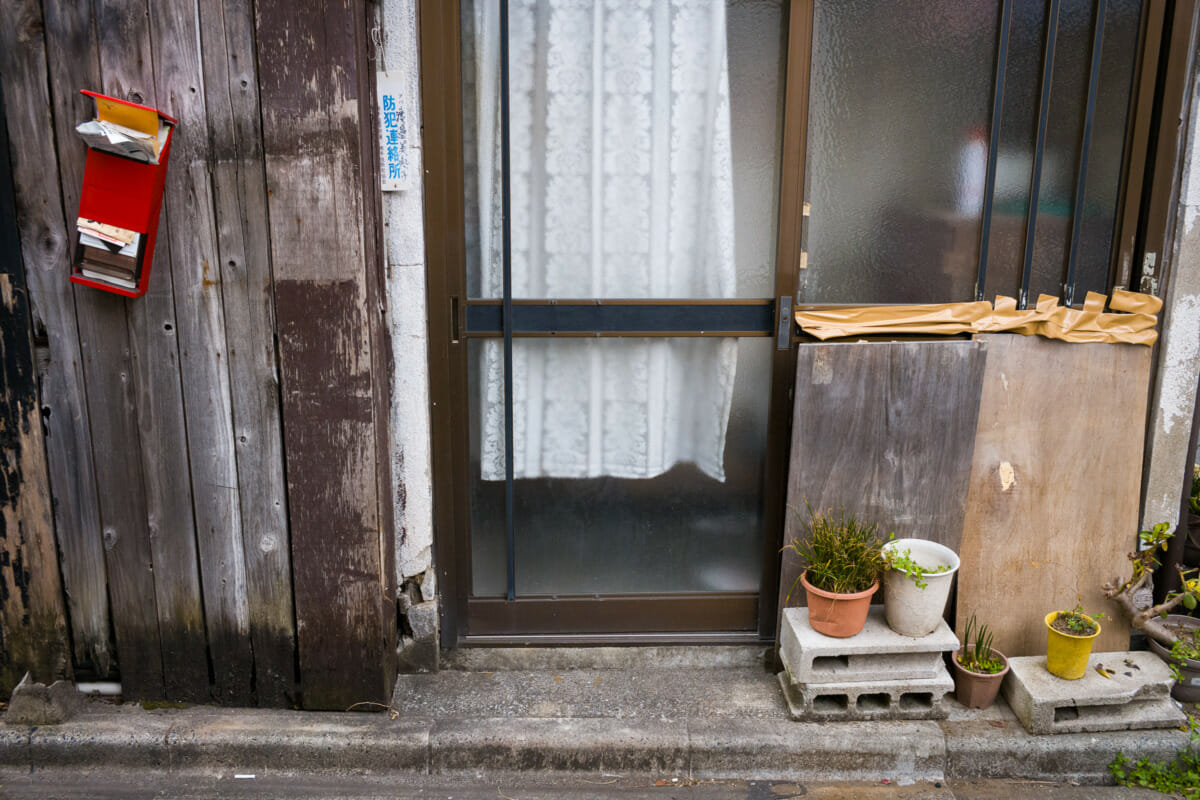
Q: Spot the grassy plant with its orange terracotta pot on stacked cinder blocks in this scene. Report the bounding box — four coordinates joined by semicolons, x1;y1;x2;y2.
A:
785;507;883;638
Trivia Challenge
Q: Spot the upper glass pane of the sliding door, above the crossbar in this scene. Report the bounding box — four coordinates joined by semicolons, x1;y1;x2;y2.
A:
462;0;787;299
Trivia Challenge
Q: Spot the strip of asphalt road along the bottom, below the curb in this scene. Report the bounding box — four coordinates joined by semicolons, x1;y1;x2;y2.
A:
0;770;1163;800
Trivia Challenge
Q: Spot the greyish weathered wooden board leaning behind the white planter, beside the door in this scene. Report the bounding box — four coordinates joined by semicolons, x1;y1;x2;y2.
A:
779;339;988;623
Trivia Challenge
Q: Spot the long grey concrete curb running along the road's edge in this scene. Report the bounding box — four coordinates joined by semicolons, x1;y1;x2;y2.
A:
0;706;1188;783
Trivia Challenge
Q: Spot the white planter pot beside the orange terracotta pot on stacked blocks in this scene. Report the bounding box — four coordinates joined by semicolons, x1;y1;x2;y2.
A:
883;539;959;637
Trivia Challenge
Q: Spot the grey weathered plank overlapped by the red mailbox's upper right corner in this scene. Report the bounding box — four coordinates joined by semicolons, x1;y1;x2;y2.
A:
149;0;257;705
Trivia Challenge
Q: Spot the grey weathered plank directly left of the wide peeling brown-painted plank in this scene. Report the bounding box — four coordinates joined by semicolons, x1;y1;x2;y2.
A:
199;0;295;706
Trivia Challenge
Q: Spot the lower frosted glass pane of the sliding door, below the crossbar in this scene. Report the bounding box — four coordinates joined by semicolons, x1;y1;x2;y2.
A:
470;338;772;596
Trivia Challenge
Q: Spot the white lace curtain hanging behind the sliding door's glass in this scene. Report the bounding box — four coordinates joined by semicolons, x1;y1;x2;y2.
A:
474;0;737;481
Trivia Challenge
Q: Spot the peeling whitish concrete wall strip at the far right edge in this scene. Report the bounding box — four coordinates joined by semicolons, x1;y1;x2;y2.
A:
1141;56;1200;537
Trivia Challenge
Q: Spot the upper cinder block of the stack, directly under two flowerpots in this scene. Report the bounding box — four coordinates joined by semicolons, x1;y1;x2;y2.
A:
779;606;959;685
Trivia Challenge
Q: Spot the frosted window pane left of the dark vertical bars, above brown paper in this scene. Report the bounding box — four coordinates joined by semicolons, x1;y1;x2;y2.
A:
799;0;998;302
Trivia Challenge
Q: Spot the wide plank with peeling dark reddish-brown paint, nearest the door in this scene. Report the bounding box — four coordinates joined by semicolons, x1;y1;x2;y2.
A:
257;0;396;709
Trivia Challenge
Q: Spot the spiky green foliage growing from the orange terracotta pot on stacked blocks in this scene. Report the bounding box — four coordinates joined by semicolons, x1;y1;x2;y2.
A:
784;503;883;597
